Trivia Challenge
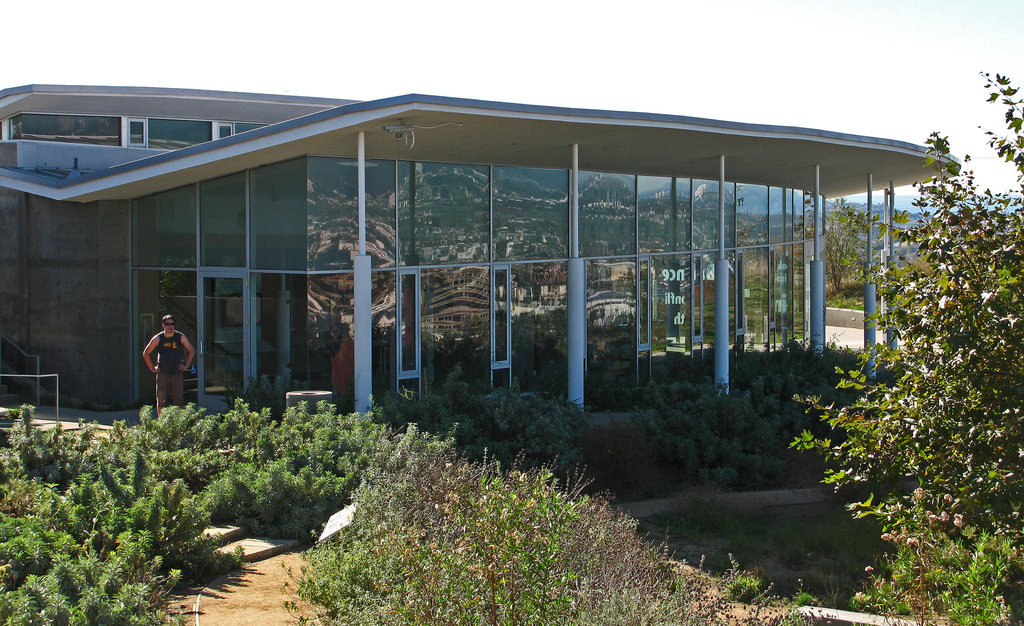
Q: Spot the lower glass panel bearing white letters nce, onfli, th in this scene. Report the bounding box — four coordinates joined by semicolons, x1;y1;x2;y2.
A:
650;254;691;378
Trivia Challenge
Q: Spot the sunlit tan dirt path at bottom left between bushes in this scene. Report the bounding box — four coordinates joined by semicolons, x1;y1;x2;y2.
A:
168;552;313;626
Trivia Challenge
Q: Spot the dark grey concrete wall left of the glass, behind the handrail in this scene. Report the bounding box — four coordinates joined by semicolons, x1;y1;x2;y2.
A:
0;191;132;404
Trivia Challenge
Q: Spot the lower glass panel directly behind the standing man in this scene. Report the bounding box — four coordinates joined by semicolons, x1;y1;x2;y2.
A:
135;269;199;405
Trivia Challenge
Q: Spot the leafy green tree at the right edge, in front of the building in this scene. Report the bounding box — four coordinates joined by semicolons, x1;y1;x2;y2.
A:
794;75;1024;616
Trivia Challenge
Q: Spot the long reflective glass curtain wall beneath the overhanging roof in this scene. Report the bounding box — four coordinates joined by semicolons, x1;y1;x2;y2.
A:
132;156;813;403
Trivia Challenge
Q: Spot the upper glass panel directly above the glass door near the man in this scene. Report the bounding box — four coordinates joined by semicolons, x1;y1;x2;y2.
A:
199;172;246;267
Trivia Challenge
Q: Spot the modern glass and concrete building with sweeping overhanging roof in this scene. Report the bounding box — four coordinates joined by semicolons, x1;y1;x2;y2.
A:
0;85;927;408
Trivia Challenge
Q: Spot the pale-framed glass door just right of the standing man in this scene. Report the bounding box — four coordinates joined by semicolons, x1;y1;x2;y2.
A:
197;272;249;411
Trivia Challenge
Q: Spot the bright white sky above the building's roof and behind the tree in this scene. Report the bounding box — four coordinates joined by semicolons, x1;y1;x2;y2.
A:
9;0;1024;195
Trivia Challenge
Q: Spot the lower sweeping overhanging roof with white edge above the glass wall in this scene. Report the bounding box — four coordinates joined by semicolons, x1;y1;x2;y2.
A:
0;94;931;202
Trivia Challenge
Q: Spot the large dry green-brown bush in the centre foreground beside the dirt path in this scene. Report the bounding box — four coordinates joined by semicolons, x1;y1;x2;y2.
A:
298;427;761;625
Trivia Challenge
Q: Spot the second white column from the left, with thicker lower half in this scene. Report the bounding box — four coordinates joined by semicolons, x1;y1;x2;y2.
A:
567;143;587;407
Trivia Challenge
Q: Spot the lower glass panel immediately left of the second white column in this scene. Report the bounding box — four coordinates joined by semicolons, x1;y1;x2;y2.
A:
511;262;568;395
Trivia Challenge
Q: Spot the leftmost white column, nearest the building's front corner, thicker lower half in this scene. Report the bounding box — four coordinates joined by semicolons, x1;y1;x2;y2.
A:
352;130;374;413
